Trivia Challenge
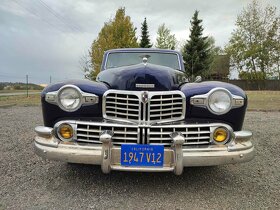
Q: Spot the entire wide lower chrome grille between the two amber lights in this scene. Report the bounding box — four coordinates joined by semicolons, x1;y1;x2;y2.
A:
76;121;211;146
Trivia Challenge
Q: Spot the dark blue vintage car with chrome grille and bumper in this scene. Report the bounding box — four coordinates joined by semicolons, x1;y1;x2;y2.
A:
34;48;254;175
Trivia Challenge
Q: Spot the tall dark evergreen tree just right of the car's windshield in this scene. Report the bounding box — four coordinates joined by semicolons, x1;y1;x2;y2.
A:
183;10;210;77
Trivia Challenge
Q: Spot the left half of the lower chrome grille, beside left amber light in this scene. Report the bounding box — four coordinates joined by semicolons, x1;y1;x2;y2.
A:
76;122;139;144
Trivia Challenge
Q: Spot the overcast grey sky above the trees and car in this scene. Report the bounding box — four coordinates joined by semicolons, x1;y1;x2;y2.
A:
0;0;280;84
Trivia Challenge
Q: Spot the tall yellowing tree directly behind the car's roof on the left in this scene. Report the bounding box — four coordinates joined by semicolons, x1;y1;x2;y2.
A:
88;8;138;80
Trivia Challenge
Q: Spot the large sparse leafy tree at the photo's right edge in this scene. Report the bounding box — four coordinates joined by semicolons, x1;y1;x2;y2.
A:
226;0;280;79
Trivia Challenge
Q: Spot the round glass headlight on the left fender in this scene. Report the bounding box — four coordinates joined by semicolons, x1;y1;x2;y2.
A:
58;85;82;112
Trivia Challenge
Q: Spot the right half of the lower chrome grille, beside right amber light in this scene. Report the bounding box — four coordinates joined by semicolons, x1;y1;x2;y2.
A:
148;125;211;145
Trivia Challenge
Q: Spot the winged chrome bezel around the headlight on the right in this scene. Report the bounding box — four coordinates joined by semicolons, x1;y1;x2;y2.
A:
190;88;245;115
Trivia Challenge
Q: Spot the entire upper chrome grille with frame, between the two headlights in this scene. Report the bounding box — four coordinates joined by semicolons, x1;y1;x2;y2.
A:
102;90;186;123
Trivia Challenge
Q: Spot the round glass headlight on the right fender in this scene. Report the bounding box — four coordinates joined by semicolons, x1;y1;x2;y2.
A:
208;89;232;115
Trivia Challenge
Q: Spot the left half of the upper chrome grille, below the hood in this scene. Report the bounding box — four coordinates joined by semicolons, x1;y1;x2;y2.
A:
103;92;140;120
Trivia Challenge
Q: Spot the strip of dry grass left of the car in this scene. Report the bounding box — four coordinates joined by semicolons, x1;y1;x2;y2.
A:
0;94;41;107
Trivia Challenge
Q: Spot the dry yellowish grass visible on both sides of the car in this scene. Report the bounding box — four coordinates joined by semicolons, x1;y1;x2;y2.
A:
0;91;280;111
